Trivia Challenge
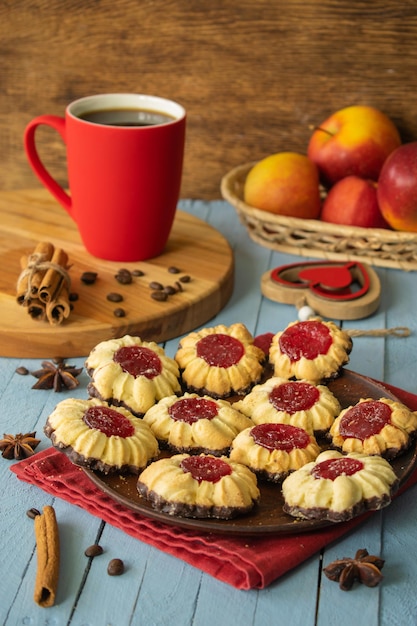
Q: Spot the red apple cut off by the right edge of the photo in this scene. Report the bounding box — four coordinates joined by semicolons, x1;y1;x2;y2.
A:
378;141;417;232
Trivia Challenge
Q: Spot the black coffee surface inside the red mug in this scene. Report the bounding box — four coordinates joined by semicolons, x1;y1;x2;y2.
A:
78;109;175;127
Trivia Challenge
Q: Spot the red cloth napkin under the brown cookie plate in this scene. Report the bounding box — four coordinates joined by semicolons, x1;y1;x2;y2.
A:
11;378;417;589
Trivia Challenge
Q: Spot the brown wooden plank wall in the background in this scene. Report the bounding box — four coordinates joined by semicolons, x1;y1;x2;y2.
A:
0;0;417;199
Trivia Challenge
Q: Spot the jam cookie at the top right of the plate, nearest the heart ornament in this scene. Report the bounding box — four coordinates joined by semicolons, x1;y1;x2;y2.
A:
269;319;352;383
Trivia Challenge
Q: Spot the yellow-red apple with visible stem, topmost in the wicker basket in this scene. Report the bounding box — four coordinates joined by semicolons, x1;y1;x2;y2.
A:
307;105;401;186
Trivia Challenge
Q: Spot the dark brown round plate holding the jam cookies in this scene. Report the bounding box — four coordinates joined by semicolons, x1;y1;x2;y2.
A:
85;370;417;535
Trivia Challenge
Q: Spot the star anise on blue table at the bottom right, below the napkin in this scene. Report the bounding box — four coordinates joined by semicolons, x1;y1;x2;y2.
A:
323;549;385;591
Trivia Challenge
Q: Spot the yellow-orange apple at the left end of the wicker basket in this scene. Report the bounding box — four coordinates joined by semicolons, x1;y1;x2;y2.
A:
244;152;321;219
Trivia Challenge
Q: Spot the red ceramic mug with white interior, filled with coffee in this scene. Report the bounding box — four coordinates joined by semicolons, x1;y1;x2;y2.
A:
24;94;186;261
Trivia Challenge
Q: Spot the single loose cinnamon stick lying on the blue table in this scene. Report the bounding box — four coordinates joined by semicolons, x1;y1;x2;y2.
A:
33;506;59;607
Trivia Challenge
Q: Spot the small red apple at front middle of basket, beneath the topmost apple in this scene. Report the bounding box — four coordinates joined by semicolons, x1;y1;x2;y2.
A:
320;176;389;228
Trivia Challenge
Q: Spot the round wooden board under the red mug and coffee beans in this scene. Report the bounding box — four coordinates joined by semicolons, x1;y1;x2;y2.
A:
0;189;234;359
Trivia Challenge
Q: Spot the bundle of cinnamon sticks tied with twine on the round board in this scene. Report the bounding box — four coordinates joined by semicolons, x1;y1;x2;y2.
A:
16;242;71;325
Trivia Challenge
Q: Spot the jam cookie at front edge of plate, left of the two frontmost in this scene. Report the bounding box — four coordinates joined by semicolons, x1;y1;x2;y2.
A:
137;454;260;520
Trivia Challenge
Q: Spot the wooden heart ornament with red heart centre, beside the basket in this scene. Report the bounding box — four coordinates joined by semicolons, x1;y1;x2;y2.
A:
261;261;381;320
